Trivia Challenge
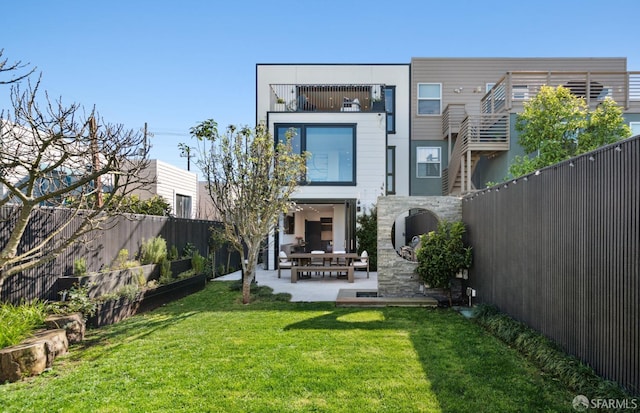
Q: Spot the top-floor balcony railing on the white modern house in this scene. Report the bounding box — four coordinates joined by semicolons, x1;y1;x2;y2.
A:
269;84;385;112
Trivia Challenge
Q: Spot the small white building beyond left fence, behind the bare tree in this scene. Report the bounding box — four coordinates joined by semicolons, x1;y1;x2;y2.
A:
132;159;198;219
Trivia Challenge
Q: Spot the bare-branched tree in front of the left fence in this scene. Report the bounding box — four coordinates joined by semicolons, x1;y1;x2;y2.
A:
0;73;149;287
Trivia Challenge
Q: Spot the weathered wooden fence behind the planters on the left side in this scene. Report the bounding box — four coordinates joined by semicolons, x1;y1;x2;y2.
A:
0;207;240;302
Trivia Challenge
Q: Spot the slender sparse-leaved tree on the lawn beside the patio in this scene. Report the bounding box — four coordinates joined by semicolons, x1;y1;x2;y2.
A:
191;119;306;304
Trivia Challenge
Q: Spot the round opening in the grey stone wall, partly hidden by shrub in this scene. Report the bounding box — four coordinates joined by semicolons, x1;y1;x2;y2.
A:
391;208;438;261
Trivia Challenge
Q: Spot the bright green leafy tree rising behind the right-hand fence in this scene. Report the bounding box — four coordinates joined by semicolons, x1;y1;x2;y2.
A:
509;86;631;176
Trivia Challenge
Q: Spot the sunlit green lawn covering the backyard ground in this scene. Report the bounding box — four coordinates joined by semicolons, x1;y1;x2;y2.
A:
0;282;575;413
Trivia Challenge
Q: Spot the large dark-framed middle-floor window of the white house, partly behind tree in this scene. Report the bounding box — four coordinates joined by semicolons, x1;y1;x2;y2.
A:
275;125;356;185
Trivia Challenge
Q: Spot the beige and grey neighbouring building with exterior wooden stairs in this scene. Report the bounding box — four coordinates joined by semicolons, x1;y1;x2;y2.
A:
410;58;640;195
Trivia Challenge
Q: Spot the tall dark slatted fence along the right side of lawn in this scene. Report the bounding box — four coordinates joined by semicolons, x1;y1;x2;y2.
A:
462;137;640;394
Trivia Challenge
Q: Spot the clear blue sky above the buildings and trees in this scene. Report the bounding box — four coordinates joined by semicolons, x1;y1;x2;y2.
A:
0;0;640;168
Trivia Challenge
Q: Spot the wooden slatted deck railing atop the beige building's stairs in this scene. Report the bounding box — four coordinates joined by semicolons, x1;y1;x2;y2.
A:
481;72;640;113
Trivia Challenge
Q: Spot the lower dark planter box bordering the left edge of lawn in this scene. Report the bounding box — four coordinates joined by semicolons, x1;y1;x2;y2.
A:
87;274;207;327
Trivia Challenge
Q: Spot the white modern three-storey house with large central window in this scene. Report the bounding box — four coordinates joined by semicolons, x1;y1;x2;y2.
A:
256;64;409;267
